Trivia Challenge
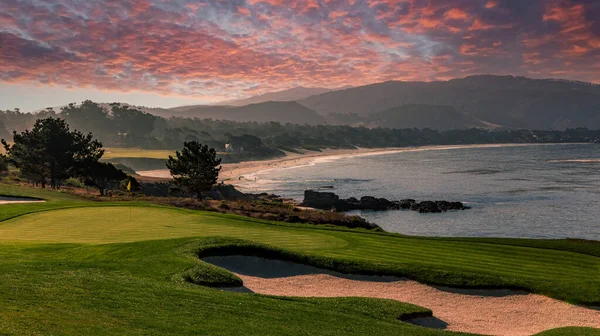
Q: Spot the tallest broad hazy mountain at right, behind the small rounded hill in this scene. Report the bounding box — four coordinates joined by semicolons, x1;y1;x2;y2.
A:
299;75;600;129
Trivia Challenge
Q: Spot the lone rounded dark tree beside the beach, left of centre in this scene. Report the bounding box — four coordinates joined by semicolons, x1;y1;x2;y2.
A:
167;141;221;199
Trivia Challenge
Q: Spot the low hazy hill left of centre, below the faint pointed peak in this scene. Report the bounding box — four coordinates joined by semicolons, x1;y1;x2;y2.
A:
148;101;325;125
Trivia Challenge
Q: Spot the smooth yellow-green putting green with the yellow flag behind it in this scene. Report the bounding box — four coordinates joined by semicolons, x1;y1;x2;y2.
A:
0;206;347;250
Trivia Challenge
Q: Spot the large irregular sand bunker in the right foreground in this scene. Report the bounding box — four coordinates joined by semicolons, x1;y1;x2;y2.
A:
203;256;600;335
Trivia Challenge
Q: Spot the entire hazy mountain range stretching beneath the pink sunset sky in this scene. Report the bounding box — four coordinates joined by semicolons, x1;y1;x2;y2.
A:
35;75;600;130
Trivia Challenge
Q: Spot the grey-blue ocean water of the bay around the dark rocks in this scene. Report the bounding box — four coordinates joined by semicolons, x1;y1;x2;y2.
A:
239;144;600;240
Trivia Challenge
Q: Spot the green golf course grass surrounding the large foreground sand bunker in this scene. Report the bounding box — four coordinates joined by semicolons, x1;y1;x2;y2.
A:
0;184;600;335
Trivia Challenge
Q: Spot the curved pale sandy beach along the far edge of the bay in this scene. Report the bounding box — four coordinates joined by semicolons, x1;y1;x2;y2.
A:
136;143;591;191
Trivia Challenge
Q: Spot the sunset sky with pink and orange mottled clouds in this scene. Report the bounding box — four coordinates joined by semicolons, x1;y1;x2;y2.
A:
0;0;600;111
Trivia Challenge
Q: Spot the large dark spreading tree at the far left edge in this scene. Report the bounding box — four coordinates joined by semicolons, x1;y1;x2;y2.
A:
2;117;104;189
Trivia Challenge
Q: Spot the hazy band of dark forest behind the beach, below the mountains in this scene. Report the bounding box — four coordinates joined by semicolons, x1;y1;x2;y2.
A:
0;100;600;159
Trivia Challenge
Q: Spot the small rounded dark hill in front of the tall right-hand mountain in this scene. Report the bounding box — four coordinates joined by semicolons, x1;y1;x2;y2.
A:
370;104;497;130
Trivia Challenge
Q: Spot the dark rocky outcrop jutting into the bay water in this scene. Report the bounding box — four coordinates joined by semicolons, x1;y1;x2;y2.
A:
300;190;470;213
